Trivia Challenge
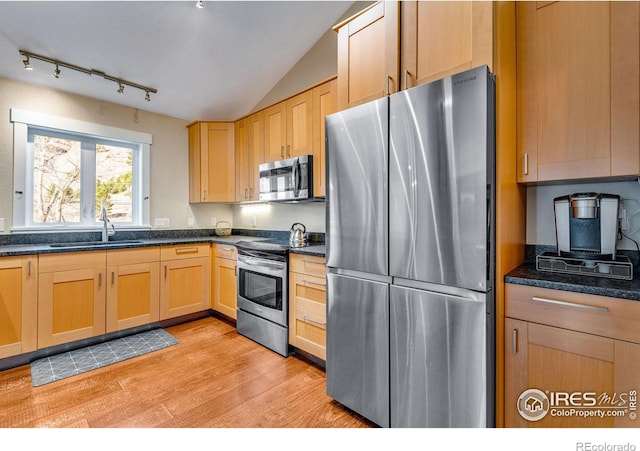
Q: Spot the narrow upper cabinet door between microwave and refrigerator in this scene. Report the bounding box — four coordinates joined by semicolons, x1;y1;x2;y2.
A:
313;79;338;197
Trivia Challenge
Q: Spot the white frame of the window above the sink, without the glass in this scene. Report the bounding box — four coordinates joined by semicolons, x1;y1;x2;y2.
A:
10;108;152;232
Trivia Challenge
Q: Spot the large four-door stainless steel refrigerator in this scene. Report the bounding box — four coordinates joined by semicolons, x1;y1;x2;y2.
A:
326;66;495;427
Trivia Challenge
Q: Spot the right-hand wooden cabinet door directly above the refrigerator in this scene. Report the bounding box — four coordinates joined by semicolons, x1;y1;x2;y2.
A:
400;1;493;89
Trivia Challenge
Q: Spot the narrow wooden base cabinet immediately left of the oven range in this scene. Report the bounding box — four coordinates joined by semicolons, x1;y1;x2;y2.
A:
213;244;238;319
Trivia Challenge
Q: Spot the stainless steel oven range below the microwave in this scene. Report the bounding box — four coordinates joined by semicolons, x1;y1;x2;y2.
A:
236;241;289;357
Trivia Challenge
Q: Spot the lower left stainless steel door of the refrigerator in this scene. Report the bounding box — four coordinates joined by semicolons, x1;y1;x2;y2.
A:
326;273;389;427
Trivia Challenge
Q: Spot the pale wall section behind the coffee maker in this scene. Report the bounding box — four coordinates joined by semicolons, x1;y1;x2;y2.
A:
527;181;640;250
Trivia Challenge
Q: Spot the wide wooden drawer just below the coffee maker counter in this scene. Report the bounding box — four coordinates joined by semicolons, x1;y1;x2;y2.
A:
505;283;640;343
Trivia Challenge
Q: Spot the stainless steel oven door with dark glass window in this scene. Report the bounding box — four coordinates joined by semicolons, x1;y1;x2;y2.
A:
238;255;287;326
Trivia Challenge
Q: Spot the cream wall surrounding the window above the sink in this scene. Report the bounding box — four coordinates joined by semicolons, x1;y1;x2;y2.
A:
0;78;233;234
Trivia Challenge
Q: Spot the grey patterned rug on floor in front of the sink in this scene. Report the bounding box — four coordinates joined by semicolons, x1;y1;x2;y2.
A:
31;329;178;387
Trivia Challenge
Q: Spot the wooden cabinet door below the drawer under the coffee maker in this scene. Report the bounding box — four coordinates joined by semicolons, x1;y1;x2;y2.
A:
505;318;616;428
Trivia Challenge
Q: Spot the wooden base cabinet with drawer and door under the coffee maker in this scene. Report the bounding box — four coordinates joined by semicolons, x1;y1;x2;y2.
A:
504;284;640;427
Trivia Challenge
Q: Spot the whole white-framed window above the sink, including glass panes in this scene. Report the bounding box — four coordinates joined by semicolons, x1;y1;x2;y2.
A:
11;110;151;230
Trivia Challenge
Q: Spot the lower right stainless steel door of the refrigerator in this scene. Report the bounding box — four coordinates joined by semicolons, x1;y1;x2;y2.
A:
390;285;493;428
